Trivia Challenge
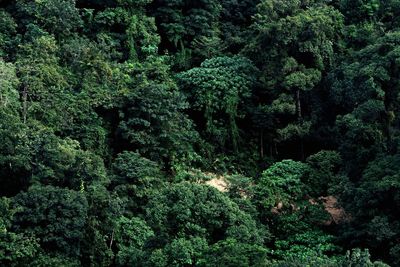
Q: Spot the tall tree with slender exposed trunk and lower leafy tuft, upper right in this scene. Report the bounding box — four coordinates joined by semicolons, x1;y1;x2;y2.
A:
244;1;343;159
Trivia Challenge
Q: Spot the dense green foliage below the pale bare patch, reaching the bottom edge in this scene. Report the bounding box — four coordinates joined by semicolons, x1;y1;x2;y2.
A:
141;183;267;266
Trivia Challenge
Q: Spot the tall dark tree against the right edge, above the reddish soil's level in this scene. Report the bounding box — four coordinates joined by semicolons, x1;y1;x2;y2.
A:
331;31;400;178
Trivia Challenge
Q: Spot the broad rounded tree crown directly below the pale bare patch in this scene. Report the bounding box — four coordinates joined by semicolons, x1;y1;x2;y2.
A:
146;183;267;264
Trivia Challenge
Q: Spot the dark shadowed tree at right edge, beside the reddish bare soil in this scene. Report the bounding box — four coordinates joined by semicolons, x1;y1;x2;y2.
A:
341;154;400;262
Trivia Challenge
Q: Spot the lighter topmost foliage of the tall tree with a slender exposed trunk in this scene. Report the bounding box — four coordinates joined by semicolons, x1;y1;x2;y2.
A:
253;1;343;70
